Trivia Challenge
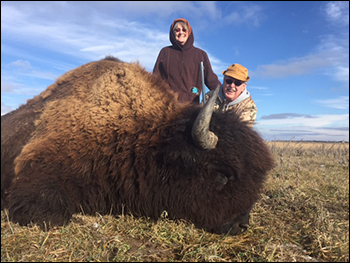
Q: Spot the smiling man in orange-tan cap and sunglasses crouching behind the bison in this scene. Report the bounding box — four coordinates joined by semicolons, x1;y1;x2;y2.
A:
206;64;257;127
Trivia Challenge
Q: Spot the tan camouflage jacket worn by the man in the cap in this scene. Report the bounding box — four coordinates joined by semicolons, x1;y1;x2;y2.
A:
205;87;258;127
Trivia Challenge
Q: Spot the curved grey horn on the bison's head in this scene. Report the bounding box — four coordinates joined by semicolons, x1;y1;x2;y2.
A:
192;85;220;150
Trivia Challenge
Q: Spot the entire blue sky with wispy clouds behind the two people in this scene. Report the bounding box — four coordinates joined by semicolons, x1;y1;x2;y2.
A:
1;1;349;141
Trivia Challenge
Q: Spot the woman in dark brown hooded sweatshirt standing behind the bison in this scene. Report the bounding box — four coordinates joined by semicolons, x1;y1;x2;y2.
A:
153;18;221;103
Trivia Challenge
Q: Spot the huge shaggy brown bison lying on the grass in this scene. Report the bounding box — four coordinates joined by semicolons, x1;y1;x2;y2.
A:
1;57;274;234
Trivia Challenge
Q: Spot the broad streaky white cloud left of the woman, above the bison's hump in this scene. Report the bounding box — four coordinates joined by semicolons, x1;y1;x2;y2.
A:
1;10;169;70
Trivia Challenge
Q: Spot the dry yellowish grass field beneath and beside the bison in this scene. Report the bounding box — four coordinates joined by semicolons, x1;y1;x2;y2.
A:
1;142;349;262
